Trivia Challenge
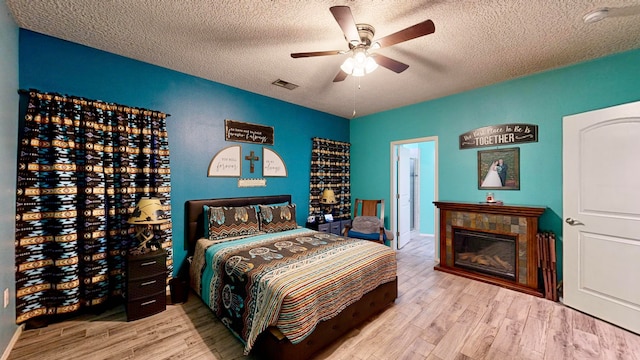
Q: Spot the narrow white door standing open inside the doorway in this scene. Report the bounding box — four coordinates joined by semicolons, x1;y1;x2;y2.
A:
396;146;411;249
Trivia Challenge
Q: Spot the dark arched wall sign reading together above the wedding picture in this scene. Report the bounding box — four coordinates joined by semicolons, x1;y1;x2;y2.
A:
459;124;538;149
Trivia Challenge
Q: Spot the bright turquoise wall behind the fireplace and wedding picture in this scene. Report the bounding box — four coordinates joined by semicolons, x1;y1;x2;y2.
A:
351;50;640;282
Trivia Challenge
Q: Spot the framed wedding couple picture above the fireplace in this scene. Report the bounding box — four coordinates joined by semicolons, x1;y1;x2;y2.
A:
478;147;520;190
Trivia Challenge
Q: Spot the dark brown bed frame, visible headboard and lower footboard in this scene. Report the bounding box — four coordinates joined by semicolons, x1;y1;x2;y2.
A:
185;195;398;360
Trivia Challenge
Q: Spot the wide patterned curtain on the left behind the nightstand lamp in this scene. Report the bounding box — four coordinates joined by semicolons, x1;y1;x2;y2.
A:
15;90;173;324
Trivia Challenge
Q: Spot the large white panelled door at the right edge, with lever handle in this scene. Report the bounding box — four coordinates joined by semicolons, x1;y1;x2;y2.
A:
562;102;640;333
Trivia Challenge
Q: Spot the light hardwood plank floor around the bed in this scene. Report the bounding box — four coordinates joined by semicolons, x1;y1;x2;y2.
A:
9;238;640;360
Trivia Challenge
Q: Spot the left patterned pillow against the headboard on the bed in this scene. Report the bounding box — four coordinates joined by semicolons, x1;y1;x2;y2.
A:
205;206;260;240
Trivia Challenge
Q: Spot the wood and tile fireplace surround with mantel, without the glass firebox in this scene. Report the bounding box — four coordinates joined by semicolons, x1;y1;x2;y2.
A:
434;201;546;296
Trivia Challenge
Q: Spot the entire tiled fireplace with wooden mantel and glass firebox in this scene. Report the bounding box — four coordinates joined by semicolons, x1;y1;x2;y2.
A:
434;201;546;296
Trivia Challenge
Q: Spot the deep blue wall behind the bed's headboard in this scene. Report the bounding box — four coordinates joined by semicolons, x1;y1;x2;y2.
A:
18;29;349;278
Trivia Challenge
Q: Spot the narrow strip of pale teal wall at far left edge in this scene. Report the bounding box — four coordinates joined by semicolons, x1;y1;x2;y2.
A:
0;1;18;356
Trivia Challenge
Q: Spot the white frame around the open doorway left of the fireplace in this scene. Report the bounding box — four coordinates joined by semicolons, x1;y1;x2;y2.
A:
389;136;440;255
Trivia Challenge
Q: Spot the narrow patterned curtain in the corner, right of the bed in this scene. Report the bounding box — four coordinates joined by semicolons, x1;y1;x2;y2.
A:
309;138;351;219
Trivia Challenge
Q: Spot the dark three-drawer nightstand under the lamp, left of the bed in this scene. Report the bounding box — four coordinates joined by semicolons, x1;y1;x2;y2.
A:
126;250;167;321
